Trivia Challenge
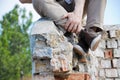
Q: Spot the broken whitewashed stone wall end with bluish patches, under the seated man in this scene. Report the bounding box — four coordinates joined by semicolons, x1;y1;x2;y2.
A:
31;21;73;77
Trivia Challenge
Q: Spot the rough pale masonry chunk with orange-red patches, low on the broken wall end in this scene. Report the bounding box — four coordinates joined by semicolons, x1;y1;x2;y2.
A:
50;54;72;74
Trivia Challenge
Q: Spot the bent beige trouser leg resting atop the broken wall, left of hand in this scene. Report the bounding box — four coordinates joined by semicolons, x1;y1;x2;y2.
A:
32;0;67;20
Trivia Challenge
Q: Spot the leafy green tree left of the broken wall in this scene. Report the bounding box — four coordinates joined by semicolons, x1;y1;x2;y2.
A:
0;5;32;80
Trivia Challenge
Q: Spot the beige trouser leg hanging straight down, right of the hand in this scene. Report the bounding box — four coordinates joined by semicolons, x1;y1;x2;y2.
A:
86;0;106;30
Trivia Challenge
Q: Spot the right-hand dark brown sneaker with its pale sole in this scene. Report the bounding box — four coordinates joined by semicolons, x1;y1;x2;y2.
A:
79;29;102;51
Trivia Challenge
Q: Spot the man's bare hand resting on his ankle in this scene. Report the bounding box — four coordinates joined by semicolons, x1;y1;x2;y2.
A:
63;12;82;33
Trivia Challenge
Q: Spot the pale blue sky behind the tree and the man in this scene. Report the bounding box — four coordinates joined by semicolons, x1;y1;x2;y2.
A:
0;0;120;25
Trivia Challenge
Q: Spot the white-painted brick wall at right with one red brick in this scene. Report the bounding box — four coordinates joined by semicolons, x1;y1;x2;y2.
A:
93;25;120;80
